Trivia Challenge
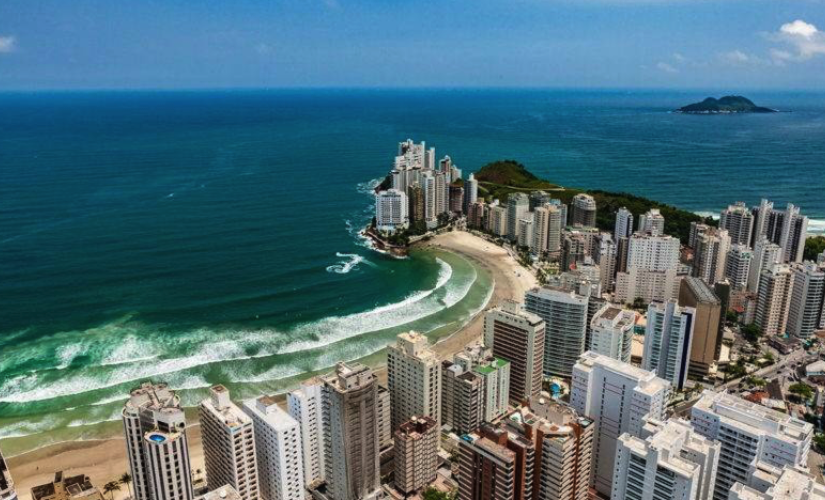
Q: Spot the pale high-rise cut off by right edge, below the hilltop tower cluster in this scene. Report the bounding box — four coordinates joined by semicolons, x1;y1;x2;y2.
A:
787;261;825;339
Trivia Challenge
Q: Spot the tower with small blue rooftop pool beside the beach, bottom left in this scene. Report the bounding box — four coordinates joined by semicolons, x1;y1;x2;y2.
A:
122;383;195;500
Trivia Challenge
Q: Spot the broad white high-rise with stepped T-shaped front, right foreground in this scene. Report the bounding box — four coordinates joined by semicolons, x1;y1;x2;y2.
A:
570;352;670;497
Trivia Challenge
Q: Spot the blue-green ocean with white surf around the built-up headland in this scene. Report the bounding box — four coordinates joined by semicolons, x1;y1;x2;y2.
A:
0;90;825;454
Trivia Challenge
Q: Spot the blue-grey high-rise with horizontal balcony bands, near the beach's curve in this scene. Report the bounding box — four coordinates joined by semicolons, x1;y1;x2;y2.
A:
524;287;588;378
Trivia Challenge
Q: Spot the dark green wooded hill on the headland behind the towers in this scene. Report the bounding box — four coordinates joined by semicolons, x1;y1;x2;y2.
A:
475;160;716;243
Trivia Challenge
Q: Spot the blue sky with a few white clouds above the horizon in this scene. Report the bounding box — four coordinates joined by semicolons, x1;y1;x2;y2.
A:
0;0;825;90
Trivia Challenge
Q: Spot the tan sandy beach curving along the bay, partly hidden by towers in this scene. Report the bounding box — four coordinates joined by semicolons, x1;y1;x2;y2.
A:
8;231;536;500
